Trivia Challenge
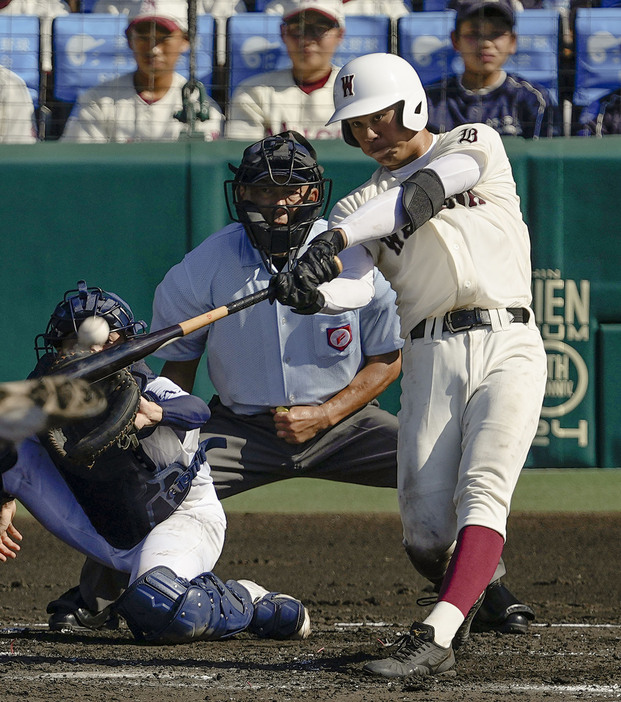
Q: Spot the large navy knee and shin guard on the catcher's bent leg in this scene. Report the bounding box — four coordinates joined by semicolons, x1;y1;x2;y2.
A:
115;566;254;644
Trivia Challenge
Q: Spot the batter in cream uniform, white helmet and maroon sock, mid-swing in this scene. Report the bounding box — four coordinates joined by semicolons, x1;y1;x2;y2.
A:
272;54;546;677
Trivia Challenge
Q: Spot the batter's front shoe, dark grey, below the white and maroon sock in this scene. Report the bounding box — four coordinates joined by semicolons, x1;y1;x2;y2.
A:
362;622;455;678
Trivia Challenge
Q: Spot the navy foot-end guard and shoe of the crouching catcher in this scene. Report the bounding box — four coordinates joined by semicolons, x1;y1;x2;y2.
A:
248;592;310;639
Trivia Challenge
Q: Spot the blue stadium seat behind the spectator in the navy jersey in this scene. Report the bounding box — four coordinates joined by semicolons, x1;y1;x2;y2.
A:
397;9;560;101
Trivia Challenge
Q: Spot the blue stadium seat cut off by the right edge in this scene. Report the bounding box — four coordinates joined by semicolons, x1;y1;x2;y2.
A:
573;7;621;105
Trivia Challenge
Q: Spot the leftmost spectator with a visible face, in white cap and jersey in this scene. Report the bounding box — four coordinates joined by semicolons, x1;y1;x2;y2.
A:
61;0;223;142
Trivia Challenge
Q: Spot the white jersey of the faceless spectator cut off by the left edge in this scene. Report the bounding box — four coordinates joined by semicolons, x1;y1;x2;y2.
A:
0;66;37;144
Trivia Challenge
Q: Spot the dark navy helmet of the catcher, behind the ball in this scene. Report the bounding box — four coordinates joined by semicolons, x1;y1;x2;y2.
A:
35;280;147;358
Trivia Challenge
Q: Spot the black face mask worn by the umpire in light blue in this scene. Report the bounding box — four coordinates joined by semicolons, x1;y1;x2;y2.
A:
224;131;332;272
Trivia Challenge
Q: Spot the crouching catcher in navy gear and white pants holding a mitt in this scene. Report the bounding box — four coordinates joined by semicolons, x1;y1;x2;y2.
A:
0;281;310;643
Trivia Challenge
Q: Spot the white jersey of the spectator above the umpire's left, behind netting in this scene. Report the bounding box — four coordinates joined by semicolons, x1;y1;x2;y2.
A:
61;73;223;143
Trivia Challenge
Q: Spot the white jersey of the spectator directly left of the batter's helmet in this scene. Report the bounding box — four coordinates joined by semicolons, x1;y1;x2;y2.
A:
225;68;341;141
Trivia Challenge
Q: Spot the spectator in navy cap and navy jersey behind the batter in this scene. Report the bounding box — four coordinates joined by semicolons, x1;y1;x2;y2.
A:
426;0;562;139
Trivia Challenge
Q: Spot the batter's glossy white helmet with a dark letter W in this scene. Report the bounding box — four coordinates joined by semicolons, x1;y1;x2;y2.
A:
327;54;428;146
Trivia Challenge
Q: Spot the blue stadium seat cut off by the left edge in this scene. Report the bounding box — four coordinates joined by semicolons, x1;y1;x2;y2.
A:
0;15;41;107
